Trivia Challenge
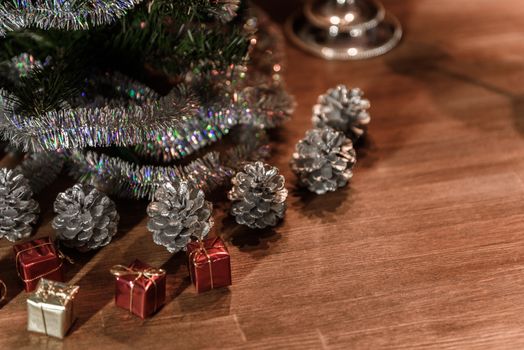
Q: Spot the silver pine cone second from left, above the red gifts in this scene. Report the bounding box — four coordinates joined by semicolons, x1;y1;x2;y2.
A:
52;184;120;252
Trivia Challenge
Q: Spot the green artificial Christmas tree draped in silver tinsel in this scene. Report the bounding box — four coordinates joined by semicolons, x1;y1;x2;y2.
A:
0;0;293;213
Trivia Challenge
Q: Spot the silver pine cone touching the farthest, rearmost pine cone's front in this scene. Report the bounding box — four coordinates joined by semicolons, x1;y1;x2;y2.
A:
291;127;356;194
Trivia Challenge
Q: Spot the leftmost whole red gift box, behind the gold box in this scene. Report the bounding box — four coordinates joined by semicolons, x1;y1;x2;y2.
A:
13;237;64;292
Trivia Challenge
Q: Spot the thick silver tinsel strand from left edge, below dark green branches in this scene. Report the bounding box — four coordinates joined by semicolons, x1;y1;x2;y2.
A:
0;85;194;152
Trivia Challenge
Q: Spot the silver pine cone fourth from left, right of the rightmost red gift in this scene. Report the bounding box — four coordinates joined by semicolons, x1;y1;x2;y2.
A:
228;162;287;228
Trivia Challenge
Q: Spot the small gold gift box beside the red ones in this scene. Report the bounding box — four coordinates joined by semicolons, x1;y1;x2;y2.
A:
27;278;79;339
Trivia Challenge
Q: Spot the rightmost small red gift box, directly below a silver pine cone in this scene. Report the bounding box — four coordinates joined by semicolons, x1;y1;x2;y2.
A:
187;237;231;293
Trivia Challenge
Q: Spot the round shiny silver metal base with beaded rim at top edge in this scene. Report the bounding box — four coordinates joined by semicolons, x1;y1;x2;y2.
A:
286;0;402;60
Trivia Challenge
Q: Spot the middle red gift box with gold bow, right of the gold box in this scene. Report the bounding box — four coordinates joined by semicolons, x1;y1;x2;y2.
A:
111;260;166;319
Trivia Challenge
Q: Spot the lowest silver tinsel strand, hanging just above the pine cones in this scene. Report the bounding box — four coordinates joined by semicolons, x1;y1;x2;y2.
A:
69;130;269;199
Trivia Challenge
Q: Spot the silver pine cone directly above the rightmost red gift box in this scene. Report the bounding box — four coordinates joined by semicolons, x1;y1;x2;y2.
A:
147;181;214;253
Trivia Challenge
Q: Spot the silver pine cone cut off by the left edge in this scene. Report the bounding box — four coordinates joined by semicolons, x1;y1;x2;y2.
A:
0;168;40;242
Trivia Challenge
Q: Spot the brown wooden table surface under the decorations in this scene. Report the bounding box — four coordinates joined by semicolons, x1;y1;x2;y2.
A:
0;0;524;349
